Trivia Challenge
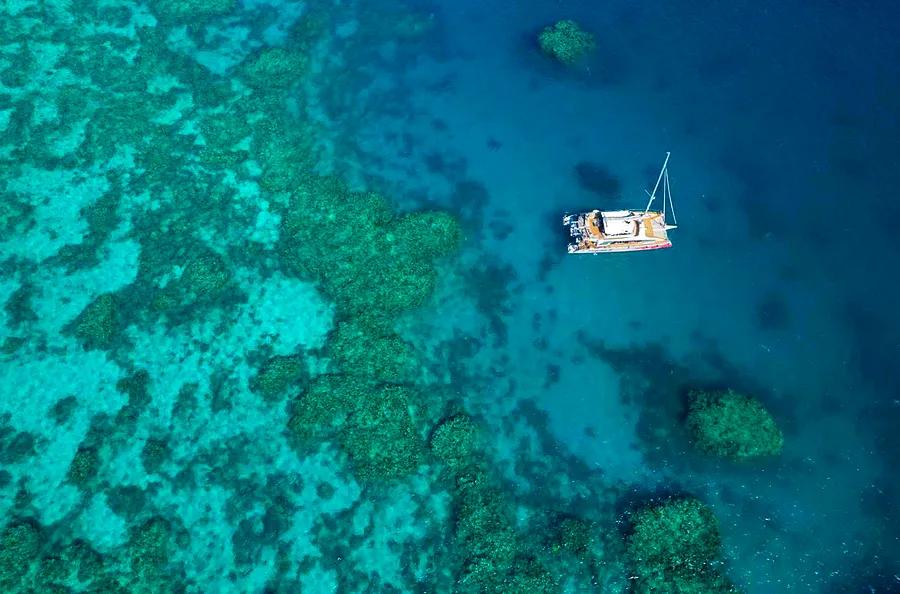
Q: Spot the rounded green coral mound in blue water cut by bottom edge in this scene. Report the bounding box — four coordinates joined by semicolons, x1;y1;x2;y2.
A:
626;498;737;594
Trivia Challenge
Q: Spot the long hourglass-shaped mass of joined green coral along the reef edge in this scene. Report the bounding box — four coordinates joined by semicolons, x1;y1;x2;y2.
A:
279;176;461;480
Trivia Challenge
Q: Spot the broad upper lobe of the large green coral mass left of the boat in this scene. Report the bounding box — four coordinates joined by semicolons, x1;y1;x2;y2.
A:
280;179;460;317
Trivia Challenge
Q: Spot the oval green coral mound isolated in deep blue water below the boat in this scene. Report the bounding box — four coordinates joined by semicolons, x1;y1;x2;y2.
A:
687;390;784;460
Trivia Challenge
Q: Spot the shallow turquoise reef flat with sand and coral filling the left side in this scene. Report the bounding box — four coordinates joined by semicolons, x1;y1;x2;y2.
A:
0;0;620;592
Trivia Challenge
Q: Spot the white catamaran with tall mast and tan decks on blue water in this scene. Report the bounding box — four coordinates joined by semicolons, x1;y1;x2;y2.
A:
563;153;678;254
